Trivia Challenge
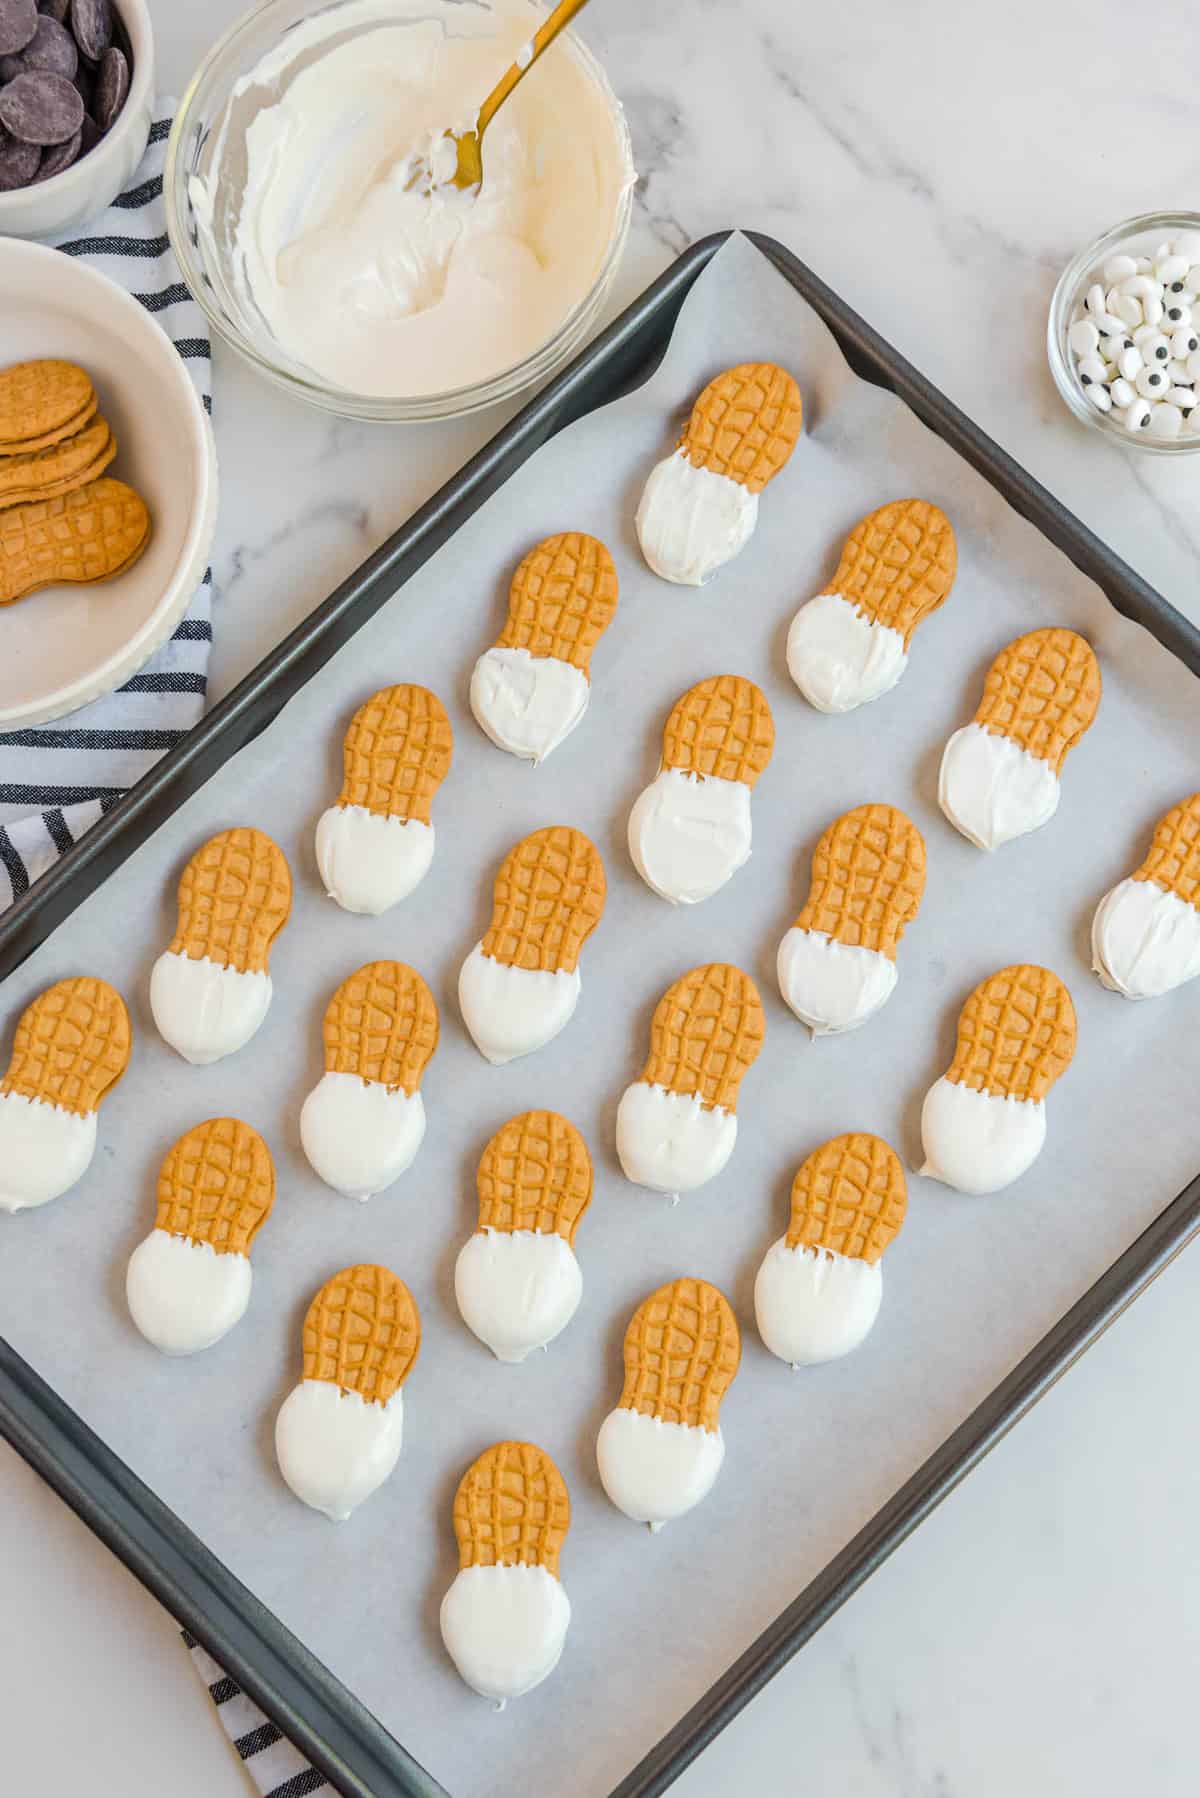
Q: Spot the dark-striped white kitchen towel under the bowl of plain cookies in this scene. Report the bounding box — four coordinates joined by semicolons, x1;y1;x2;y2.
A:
0;101;212;912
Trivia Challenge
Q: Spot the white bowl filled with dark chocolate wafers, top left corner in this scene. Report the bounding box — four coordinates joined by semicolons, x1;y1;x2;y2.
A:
0;0;155;237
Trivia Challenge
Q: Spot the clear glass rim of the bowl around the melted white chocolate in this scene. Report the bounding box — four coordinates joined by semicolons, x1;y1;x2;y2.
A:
164;0;635;424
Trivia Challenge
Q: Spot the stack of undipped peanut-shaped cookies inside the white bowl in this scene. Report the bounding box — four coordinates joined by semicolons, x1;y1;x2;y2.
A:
0;361;149;606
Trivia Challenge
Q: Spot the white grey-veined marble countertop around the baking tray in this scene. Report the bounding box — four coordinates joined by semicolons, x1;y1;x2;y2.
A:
0;0;1200;1798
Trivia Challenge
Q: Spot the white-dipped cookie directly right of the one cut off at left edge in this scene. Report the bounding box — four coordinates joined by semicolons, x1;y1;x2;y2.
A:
300;962;439;1199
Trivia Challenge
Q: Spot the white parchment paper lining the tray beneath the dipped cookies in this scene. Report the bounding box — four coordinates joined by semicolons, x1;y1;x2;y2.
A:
0;231;1200;1793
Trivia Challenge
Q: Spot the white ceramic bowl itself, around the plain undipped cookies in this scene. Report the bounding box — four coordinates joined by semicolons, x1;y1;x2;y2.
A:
0;237;218;730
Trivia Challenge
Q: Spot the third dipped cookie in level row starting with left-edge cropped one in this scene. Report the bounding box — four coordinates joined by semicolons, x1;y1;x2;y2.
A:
617;962;766;1199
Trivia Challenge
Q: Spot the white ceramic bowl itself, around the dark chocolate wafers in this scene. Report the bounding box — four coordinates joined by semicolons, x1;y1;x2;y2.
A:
0;0;155;240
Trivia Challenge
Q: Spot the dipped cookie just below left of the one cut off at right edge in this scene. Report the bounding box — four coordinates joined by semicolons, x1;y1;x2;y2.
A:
921;962;1076;1192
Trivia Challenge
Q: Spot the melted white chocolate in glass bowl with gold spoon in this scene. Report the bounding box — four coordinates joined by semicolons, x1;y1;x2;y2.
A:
189;0;633;399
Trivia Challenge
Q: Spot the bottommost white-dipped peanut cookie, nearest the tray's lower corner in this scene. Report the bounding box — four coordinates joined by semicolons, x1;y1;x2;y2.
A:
441;1442;570;1710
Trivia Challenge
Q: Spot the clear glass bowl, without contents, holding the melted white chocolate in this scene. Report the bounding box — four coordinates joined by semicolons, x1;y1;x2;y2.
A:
164;0;633;423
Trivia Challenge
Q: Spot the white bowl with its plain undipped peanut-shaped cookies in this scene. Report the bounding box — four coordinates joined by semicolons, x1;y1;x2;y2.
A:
0;237;218;729
